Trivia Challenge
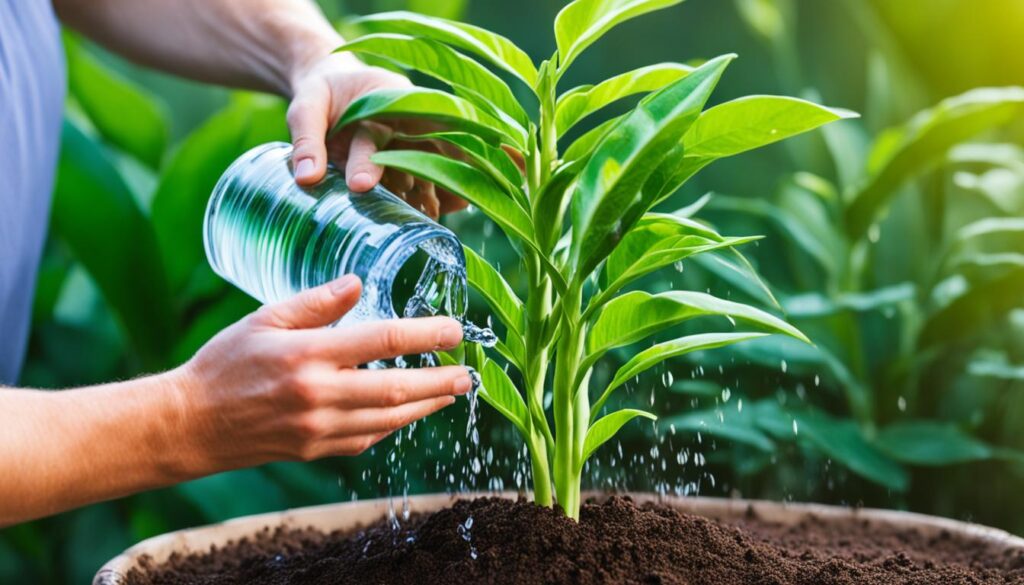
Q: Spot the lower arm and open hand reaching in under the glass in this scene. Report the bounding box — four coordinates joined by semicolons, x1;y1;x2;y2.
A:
0;278;471;527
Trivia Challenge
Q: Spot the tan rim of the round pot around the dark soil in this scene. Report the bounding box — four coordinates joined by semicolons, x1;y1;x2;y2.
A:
92;493;1024;585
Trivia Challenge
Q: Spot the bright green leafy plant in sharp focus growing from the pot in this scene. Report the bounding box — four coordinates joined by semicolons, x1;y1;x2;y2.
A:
338;0;851;518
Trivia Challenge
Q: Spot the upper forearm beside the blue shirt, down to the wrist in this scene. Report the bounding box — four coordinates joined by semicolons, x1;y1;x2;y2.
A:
54;0;342;96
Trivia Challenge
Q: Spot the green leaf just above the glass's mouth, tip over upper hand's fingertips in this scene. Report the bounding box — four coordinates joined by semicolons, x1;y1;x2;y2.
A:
372;151;532;242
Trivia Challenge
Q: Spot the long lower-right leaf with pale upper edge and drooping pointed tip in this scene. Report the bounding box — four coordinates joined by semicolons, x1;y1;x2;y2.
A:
587;291;810;354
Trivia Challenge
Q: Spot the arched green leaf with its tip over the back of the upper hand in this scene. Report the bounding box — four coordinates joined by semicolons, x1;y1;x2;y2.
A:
332;87;526;151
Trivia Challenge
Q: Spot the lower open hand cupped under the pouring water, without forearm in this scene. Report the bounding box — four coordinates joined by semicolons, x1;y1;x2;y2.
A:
172;276;472;476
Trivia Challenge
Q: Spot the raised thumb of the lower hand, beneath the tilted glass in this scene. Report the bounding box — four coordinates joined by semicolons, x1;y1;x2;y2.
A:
254;275;362;329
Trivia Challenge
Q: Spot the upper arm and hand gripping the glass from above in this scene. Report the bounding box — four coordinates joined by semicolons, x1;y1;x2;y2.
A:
54;0;465;216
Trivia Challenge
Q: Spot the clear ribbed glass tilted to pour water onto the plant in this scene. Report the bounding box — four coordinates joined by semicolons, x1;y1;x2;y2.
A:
203;142;475;323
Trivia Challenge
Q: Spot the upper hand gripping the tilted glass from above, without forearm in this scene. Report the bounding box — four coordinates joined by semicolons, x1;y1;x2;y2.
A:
288;53;466;218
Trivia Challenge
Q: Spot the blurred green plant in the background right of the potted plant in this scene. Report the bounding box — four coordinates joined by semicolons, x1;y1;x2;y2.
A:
663;0;1024;499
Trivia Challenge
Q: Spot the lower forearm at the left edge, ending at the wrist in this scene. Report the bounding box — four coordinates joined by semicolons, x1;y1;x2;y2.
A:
0;373;195;526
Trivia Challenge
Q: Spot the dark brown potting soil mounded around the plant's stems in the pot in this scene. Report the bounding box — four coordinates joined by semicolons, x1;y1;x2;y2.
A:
121;497;1024;585
